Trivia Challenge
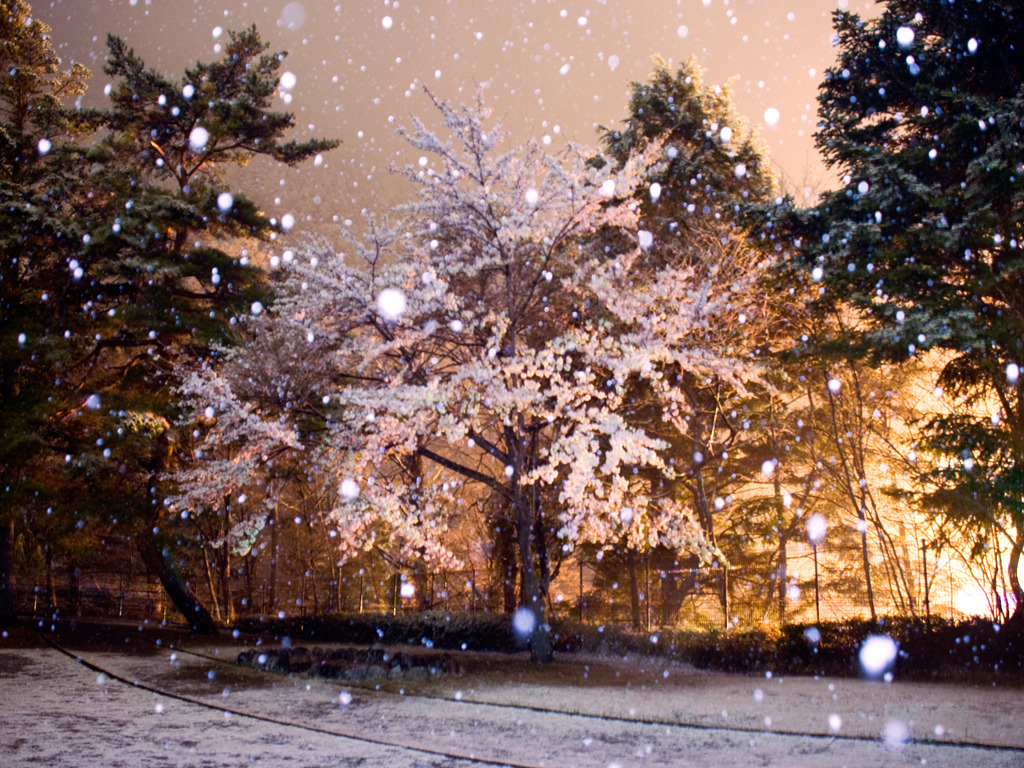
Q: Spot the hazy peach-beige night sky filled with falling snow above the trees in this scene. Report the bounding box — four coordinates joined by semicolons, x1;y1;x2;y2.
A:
34;0;873;233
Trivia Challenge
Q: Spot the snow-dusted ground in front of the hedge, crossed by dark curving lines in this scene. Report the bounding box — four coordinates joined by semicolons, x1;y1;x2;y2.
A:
0;627;1024;768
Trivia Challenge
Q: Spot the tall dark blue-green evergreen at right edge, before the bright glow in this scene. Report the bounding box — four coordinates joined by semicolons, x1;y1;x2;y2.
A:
790;0;1024;617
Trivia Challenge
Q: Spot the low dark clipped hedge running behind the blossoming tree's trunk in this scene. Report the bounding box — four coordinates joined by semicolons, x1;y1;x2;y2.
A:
237;612;1024;682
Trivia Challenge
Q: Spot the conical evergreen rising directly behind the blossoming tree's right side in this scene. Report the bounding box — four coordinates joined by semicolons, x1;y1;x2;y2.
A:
602;58;784;622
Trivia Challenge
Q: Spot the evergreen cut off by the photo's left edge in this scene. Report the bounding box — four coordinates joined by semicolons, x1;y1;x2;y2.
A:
0;0;99;623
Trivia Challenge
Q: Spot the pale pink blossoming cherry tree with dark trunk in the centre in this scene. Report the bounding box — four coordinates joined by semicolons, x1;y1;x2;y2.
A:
173;85;759;660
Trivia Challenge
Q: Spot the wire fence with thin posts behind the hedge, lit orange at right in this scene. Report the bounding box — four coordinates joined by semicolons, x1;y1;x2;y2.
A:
15;548;1010;630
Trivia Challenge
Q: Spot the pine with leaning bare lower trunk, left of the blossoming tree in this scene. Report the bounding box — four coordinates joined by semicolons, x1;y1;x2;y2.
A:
83;27;338;631
